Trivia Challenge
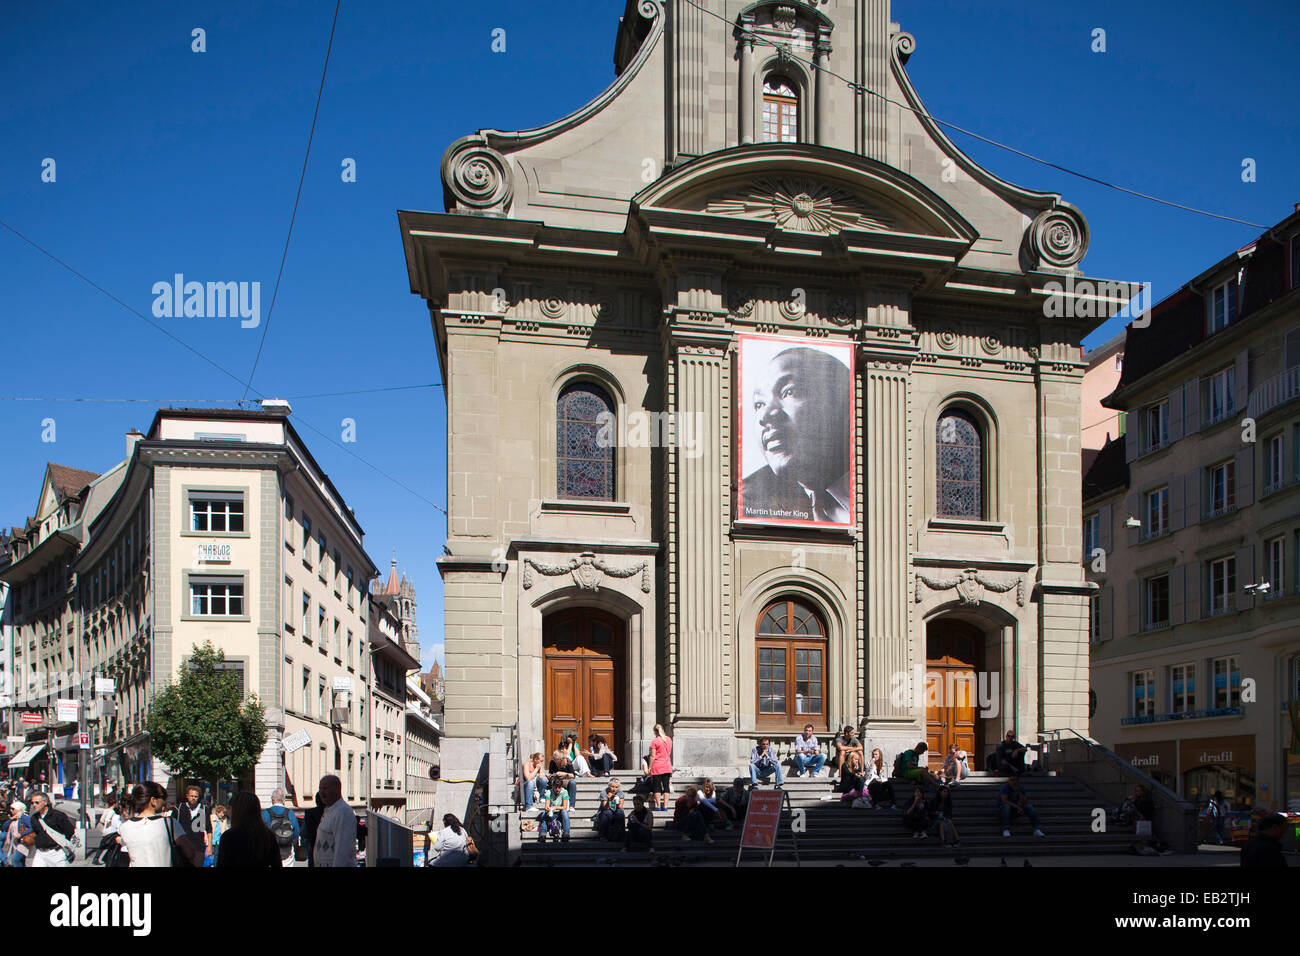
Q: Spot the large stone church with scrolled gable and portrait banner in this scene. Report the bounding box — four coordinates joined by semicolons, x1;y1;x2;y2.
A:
399;0;1115;779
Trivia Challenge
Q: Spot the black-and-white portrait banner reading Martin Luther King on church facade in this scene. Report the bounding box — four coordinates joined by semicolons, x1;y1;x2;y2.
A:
737;336;853;527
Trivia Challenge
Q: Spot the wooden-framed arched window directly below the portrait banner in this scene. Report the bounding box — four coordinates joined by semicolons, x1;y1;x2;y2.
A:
754;598;826;727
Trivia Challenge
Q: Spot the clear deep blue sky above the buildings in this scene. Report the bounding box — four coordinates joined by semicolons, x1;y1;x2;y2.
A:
0;0;1300;663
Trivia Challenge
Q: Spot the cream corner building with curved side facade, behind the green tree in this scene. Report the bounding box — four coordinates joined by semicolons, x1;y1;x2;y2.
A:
5;403;376;806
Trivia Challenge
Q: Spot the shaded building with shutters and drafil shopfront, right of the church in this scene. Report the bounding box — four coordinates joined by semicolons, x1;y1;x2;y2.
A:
1083;212;1300;809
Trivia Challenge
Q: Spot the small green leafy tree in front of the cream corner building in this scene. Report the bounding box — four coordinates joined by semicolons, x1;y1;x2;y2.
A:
148;641;267;780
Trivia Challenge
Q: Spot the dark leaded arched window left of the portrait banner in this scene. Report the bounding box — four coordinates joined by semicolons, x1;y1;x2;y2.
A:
555;381;614;501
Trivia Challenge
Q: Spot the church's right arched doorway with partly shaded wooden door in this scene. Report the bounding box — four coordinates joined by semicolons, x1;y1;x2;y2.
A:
926;620;984;767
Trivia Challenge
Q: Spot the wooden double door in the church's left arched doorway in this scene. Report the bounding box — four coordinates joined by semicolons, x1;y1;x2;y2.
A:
542;607;624;766
